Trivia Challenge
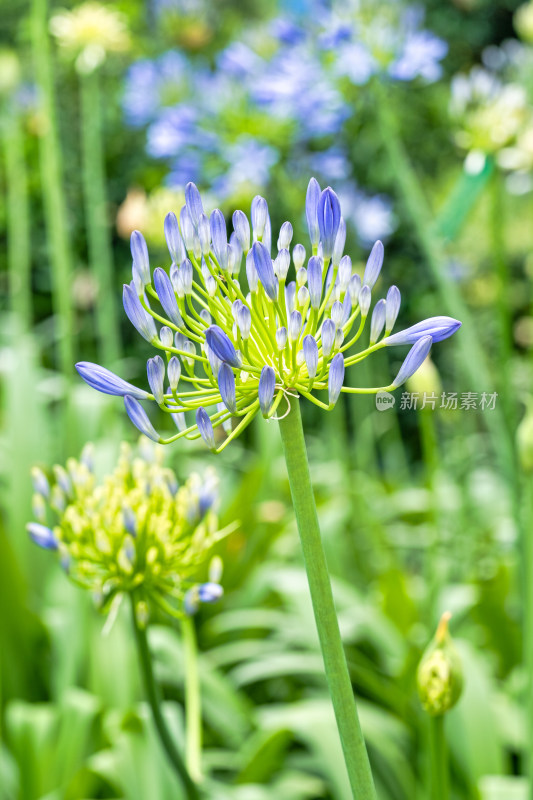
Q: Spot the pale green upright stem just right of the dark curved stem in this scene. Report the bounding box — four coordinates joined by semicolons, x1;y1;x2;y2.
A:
181;617;202;781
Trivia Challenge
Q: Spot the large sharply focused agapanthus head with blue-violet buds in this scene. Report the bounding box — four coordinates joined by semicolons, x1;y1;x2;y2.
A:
77;178;461;452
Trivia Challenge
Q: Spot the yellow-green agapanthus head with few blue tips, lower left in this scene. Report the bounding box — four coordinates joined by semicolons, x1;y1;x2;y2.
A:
27;440;232;616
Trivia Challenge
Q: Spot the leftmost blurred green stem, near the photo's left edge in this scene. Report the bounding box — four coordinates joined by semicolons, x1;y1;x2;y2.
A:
3;101;32;331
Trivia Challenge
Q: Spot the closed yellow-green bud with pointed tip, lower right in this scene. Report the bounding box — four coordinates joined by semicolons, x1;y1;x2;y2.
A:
417;611;463;717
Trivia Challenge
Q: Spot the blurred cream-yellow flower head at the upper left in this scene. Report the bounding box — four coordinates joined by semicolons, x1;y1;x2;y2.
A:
50;2;130;72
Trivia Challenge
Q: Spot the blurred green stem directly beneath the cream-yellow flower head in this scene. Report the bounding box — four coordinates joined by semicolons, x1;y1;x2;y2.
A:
80;70;120;364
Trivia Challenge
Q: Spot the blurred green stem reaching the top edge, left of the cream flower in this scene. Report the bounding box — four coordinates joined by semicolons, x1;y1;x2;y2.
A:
32;0;74;379
